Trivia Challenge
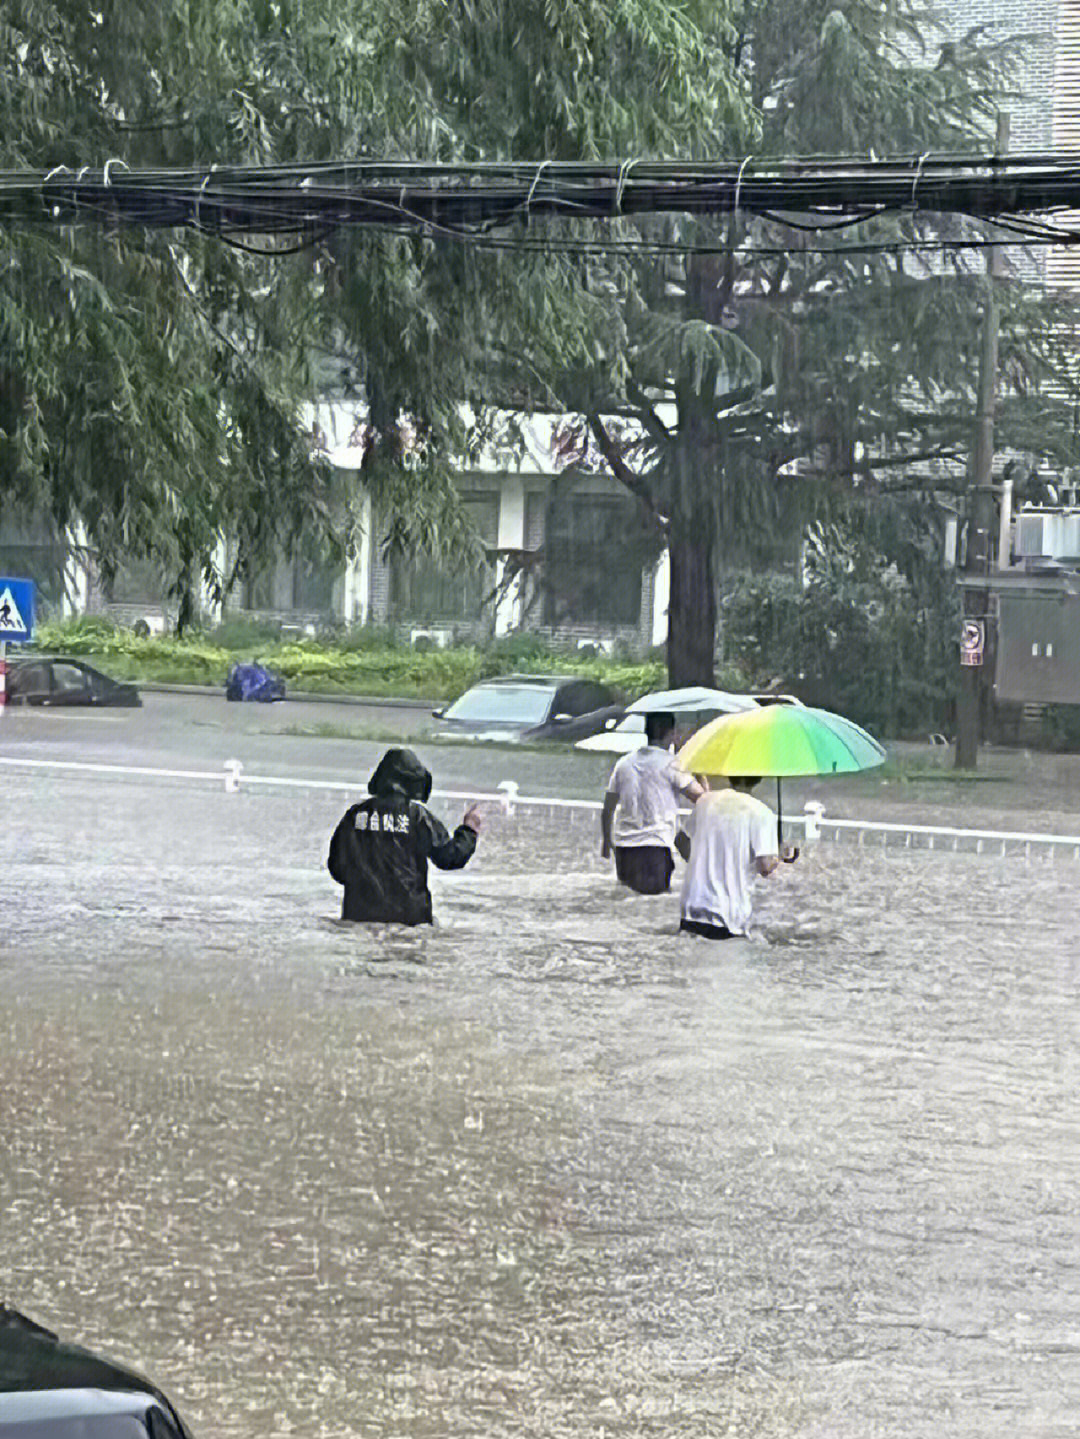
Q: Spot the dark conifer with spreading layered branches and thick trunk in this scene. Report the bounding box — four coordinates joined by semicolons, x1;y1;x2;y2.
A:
506;0;1035;685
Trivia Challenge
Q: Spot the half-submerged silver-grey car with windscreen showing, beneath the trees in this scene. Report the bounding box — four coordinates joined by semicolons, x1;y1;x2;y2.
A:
434;675;623;744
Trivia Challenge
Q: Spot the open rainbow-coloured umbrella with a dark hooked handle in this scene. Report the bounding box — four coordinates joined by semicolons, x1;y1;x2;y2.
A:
679;705;886;832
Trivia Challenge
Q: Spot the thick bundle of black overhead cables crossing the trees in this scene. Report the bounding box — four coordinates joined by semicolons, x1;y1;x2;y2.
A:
0;153;1080;245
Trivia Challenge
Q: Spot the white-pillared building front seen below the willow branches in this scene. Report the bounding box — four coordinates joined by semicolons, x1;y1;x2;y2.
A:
0;404;667;652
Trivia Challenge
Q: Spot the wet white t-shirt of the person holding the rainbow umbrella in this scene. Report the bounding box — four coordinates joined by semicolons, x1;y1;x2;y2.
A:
683;790;778;934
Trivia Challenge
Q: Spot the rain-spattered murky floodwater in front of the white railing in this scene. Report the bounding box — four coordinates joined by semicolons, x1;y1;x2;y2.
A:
0;771;1080;1439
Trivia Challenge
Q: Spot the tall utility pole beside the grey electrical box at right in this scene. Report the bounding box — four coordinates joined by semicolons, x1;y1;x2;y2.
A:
955;114;1010;770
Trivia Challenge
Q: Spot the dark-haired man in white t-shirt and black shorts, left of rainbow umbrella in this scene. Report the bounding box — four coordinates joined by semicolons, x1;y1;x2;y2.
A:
600;714;705;895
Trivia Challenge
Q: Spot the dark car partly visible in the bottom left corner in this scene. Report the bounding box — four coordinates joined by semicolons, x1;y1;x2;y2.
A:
0;1305;191;1439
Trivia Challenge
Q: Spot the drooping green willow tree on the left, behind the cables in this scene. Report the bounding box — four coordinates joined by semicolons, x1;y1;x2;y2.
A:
0;0;746;621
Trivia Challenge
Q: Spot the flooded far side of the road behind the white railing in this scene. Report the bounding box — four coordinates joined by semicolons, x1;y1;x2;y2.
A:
0;692;1080;835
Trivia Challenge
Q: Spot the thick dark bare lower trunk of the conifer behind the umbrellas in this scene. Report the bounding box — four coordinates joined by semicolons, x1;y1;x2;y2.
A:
667;515;716;689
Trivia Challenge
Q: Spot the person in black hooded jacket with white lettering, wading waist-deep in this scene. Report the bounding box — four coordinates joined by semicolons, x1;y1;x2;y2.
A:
326;750;480;924
